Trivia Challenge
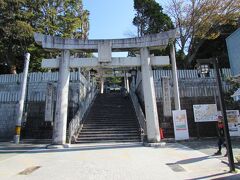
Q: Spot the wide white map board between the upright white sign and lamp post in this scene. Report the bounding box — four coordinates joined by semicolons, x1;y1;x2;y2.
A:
193;104;218;122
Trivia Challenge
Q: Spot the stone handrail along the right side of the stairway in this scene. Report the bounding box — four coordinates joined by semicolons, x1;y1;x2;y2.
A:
129;89;147;140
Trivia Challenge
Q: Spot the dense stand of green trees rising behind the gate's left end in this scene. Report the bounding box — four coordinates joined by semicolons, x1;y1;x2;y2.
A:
0;0;89;73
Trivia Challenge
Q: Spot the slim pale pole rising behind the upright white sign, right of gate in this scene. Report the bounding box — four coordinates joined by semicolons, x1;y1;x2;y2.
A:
170;44;181;110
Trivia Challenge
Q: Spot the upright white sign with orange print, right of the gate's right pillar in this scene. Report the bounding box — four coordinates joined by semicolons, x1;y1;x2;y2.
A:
172;110;189;140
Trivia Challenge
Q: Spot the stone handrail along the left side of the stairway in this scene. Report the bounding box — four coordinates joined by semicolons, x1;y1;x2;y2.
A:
68;87;98;144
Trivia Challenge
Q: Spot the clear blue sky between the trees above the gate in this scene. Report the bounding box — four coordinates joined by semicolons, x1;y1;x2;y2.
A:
83;0;168;39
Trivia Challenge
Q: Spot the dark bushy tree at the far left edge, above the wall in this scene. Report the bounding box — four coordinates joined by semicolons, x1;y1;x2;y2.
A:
0;0;33;73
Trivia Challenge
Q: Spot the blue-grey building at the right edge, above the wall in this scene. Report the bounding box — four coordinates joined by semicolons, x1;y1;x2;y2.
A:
226;28;240;79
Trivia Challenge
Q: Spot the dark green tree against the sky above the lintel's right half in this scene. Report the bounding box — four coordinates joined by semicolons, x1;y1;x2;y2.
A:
133;0;173;36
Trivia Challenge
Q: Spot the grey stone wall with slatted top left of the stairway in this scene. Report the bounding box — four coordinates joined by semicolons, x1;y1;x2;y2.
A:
0;82;83;140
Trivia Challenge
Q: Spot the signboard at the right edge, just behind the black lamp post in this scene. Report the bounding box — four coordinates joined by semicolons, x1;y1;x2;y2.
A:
218;110;240;136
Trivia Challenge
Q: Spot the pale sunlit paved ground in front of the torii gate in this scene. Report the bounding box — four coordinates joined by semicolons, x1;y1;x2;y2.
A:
0;143;240;180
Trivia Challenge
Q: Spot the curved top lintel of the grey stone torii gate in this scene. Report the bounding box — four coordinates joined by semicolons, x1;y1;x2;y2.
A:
34;29;176;52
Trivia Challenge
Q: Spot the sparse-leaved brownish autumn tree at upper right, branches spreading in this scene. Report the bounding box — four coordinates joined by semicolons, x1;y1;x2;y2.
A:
167;0;240;66
